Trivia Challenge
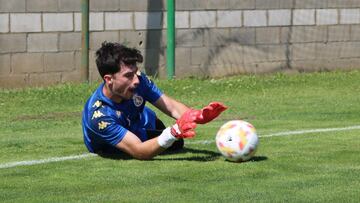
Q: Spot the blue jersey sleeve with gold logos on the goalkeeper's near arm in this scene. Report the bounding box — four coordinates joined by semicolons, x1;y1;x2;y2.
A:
90;110;127;146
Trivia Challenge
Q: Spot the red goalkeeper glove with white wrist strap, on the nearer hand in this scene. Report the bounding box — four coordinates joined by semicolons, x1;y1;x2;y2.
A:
171;109;201;138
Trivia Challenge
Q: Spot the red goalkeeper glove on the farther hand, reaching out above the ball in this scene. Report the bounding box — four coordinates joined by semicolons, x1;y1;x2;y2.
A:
195;102;227;124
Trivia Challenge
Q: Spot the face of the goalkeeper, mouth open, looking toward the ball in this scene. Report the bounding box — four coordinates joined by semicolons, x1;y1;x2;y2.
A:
106;64;139;100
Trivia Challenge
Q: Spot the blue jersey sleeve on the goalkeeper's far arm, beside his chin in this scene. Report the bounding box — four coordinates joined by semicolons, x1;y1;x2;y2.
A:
139;73;163;103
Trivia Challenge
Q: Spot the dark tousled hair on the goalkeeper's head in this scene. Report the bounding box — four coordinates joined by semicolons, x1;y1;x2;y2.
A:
96;41;143;78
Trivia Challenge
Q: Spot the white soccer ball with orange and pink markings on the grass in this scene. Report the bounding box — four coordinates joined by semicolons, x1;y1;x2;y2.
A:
216;120;259;162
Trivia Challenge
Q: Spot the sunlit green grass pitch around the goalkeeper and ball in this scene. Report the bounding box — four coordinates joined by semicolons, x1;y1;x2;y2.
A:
0;71;360;202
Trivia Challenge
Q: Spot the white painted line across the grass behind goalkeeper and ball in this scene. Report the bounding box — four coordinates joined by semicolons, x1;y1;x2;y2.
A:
0;125;360;169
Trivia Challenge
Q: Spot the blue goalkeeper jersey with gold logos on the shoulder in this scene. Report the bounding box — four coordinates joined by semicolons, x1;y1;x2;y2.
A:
82;73;162;152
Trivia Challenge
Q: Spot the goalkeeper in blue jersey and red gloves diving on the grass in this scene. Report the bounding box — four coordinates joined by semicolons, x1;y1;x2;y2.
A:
82;42;226;160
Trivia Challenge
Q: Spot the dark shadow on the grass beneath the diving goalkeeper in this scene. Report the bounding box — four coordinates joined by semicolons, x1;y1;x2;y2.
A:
98;147;221;161
